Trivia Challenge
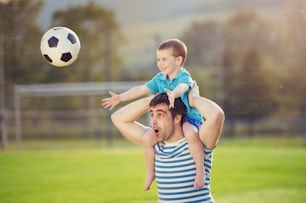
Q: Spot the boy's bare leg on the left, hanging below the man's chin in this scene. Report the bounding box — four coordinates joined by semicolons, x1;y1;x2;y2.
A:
143;129;157;191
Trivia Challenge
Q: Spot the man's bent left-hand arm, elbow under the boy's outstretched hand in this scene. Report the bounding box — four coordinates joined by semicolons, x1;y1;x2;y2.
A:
111;96;153;145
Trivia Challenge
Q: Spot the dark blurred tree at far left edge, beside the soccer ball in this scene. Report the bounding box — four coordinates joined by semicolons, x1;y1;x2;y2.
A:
0;0;43;148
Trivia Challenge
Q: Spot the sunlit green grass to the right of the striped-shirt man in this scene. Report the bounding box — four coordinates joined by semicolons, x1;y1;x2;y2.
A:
213;139;306;203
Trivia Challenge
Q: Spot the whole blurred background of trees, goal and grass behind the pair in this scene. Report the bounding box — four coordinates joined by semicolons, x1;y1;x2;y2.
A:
0;0;306;203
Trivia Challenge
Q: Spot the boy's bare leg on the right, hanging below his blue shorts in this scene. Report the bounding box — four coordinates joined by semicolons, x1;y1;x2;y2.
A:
183;122;205;190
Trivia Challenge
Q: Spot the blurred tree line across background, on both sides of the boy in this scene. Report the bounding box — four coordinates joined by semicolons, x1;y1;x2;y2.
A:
0;0;306;123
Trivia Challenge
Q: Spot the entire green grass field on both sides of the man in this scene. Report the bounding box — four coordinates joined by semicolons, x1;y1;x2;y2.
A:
0;138;306;203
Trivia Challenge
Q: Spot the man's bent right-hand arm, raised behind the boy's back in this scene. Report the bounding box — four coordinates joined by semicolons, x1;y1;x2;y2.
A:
189;82;225;149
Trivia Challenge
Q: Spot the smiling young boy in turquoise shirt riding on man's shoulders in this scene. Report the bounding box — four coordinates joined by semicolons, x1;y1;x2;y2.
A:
102;39;205;190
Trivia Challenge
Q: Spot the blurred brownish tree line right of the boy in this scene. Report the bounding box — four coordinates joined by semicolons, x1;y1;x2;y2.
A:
182;2;306;120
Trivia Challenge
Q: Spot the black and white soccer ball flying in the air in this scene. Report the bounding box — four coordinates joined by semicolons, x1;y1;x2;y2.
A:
40;27;81;67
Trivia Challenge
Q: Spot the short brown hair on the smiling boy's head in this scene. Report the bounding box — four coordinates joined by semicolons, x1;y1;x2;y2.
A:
157;39;188;66
